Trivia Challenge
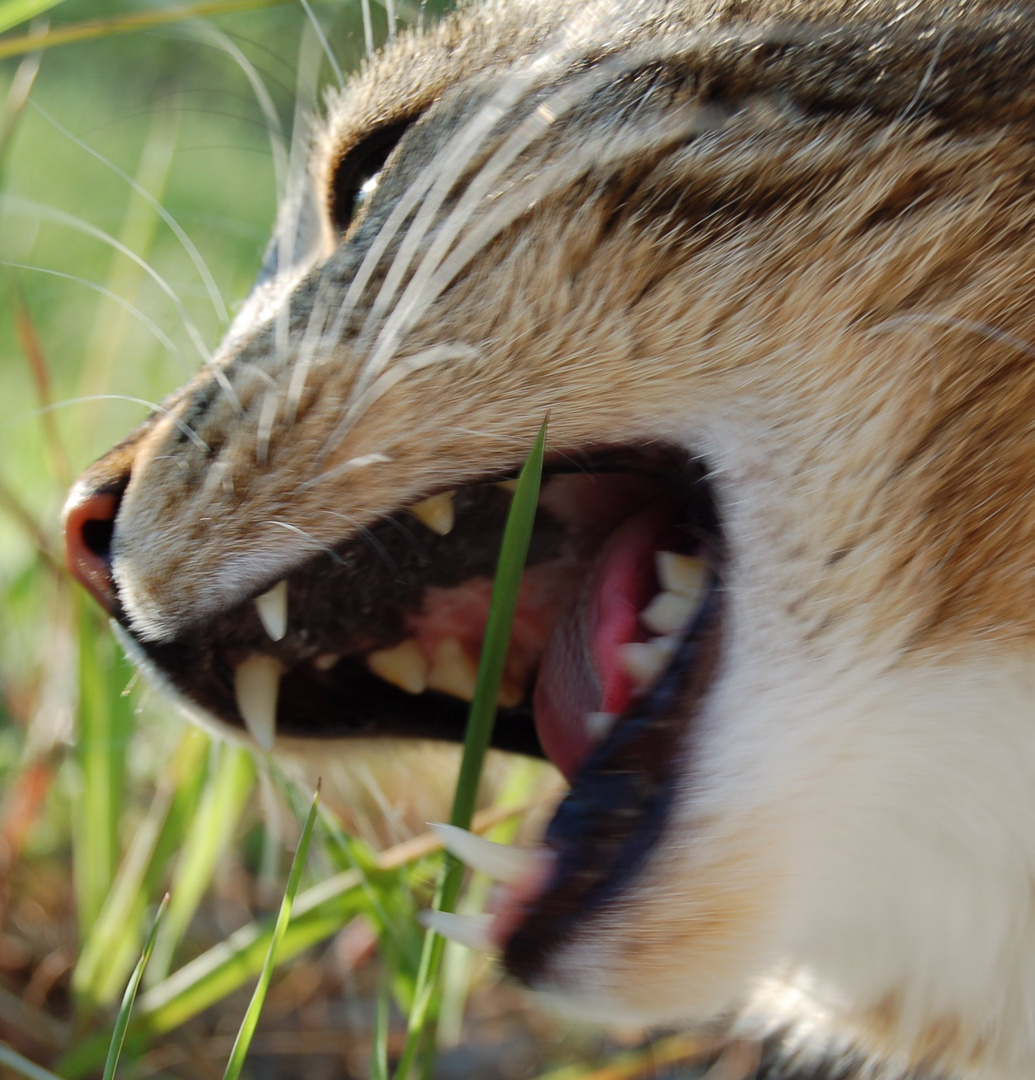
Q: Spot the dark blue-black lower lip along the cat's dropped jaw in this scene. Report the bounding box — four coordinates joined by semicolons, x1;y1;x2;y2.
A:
503;570;725;985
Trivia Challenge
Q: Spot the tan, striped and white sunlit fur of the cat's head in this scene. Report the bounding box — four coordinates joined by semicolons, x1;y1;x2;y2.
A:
75;0;1035;1080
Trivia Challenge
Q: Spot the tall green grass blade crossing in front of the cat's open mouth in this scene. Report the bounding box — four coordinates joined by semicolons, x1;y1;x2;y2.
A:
395;420;548;1080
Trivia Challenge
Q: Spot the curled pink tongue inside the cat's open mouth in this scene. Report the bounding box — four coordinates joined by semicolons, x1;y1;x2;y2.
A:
533;507;672;780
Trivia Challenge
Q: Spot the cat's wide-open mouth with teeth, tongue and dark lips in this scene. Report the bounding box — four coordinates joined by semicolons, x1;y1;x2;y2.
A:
111;448;722;978
